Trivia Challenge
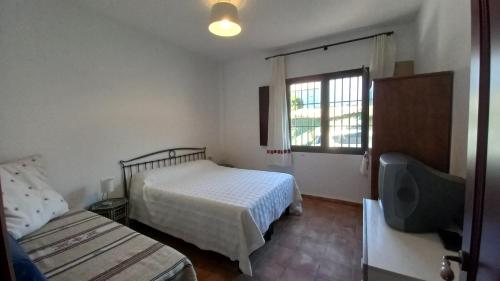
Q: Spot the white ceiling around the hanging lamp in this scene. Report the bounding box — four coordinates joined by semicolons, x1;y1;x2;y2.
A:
78;0;422;60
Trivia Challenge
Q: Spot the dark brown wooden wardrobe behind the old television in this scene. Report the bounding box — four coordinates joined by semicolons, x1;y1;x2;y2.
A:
371;72;453;199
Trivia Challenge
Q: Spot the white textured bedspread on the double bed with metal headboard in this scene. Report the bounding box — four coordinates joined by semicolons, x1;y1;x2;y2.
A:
130;160;302;275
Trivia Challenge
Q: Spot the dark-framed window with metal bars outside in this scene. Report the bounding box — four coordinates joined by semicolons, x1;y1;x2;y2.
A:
287;68;368;154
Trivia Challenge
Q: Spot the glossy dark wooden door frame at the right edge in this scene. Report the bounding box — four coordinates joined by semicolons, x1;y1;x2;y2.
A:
461;0;491;281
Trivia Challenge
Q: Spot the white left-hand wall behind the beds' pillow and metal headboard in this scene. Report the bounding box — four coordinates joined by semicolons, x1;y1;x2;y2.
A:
0;0;219;206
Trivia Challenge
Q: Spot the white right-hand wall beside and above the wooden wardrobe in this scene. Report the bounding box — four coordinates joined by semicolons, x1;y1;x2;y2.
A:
416;0;471;176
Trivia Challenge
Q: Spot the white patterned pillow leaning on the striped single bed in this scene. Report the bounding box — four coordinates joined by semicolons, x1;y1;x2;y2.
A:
0;155;68;239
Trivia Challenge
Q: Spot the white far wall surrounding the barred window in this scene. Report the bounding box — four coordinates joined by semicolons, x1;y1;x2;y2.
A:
221;23;415;202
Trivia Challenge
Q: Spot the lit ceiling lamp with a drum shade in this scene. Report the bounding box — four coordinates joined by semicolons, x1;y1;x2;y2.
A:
208;2;241;37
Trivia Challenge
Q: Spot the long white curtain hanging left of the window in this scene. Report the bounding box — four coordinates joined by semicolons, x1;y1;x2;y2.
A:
267;57;292;166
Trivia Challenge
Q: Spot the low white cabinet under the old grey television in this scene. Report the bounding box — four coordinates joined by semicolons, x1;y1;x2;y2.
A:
363;199;460;281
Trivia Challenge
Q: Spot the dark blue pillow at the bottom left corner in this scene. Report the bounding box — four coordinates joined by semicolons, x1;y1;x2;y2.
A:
7;232;47;281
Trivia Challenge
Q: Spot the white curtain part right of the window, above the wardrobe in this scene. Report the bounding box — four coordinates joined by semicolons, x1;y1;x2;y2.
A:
370;34;396;82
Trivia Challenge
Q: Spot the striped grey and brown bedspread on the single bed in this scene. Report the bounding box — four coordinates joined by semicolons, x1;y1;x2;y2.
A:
19;210;196;281
